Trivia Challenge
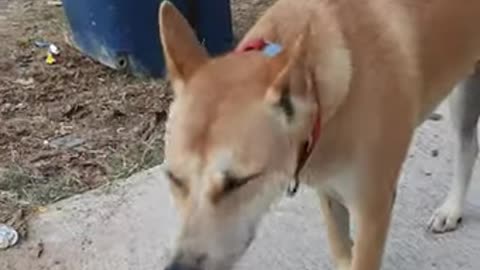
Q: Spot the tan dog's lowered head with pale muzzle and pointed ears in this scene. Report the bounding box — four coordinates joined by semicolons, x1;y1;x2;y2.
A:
160;1;332;270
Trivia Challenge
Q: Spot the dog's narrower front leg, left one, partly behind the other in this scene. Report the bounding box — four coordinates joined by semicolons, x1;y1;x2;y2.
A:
317;190;353;270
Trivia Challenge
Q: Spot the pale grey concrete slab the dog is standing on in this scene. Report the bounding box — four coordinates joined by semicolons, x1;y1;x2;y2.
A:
0;100;480;270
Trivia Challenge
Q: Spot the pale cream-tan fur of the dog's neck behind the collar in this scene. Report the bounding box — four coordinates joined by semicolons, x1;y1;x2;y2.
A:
244;0;353;129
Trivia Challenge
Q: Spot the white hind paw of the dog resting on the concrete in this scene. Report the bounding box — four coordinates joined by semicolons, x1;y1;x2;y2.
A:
429;201;462;233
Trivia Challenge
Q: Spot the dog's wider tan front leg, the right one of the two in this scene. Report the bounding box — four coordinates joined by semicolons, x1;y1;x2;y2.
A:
348;147;408;270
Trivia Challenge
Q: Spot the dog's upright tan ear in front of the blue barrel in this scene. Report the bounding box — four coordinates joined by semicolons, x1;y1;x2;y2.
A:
159;1;208;90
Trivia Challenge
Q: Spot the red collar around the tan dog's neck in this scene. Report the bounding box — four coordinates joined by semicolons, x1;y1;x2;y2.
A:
234;38;322;196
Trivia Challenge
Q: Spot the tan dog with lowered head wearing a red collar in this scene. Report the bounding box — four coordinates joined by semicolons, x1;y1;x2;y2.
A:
160;0;480;270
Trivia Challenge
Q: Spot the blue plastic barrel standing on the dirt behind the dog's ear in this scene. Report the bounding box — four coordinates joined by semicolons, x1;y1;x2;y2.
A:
63;0;233;77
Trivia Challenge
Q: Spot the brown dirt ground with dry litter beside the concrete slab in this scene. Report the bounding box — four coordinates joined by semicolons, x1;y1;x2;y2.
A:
0;0;272;233
